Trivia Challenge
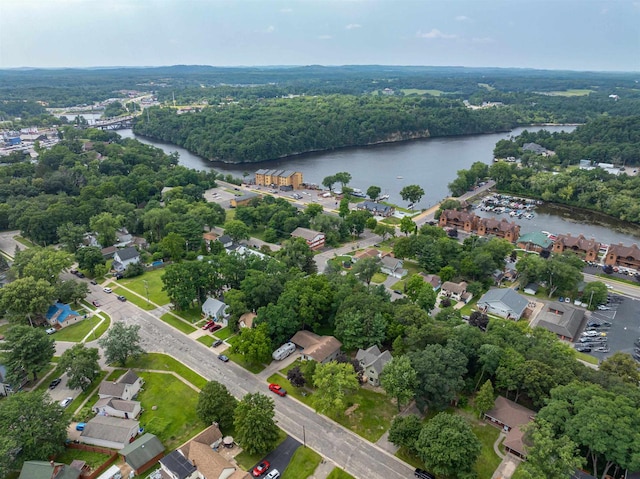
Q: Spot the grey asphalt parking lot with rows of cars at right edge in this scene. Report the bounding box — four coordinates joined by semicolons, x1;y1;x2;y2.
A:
576;294;640;360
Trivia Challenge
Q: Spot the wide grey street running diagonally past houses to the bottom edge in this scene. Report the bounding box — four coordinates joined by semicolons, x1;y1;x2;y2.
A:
89;286;413;479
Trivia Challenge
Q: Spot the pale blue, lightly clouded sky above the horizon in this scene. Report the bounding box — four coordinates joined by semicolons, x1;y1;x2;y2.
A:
0;0;640;71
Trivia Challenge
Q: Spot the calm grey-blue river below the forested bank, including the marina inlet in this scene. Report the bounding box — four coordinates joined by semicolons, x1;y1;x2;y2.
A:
118;126;640;244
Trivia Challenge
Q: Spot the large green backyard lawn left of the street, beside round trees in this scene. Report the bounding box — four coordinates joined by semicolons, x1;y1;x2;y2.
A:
138;372;203;451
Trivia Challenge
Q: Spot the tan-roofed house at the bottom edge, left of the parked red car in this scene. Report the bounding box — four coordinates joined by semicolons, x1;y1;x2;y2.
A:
180;425;251;479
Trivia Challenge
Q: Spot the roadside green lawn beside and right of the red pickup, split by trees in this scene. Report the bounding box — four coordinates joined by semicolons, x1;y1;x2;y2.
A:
268;373;397;442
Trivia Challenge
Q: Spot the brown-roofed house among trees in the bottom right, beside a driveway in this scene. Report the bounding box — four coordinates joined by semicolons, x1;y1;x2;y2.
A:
484;396;536;459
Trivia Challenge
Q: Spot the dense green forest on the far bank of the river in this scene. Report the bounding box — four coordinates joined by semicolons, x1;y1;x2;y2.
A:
134;95;523;162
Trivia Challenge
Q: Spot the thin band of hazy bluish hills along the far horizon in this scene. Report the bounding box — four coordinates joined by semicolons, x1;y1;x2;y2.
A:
0;63;640;73
